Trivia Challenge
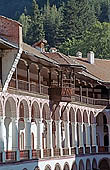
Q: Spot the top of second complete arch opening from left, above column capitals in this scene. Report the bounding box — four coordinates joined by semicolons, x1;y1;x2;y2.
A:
19;99;29;118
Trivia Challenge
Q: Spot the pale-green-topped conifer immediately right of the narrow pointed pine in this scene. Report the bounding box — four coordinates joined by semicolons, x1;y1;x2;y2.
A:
43;1;62;47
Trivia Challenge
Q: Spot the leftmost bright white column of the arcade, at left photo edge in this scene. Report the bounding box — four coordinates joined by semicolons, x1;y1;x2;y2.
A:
0;117;6;162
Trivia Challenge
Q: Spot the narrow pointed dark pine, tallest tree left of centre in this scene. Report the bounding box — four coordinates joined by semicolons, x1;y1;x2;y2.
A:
26;0;45;45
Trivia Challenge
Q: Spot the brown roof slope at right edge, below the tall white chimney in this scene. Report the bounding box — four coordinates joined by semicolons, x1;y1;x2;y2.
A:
71;57;110;82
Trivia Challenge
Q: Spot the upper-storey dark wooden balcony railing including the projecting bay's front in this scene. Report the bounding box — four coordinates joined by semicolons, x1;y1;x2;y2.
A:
9;78;110;106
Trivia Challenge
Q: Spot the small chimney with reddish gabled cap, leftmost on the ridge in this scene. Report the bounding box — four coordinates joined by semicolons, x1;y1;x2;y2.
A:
32;40;47;52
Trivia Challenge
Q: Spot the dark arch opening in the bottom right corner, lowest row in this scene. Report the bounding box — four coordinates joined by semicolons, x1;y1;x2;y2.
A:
98;158;110;170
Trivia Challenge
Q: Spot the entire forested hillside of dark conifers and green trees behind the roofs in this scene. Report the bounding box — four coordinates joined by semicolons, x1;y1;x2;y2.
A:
0;0;110;58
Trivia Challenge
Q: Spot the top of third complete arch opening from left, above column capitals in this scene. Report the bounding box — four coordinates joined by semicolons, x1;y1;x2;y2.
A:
31;101;41;121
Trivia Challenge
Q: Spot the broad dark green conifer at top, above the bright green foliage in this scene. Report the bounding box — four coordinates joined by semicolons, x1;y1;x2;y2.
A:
61;0;96;40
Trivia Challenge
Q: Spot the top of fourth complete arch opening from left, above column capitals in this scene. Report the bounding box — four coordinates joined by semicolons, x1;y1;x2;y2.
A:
42;103;51;120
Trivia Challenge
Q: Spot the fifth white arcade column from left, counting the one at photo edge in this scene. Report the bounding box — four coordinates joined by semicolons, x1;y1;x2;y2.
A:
46;120;53;156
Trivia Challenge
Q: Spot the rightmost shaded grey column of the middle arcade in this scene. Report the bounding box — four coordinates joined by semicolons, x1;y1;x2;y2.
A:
91;124;98;152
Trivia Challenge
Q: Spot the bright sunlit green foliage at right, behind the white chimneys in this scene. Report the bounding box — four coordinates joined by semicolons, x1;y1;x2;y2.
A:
59;22;110;58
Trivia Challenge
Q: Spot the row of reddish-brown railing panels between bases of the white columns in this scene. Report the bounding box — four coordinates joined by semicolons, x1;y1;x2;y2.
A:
0;146;110;163
